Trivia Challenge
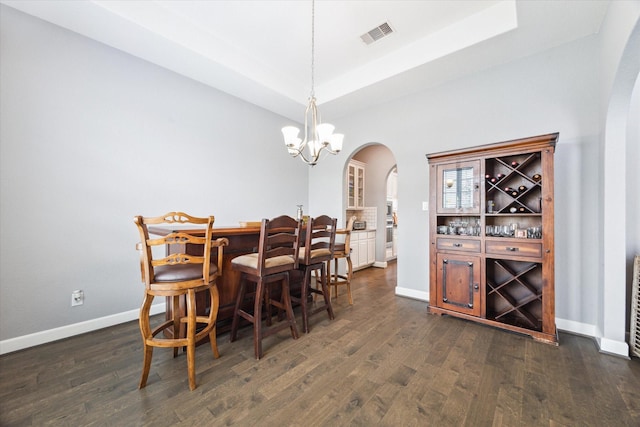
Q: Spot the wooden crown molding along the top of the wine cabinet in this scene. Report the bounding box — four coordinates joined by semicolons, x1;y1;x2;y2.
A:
427;132;559;162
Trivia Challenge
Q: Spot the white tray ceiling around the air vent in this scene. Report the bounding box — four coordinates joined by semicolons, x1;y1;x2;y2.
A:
0;0;610;121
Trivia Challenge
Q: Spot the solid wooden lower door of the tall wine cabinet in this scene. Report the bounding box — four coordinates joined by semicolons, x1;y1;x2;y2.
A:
436;253;480;316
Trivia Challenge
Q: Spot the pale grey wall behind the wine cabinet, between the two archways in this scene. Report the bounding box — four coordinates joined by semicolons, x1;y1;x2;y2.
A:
310;36;601;332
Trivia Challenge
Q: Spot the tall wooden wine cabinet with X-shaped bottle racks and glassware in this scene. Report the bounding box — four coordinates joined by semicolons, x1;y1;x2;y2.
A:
427;133;558;344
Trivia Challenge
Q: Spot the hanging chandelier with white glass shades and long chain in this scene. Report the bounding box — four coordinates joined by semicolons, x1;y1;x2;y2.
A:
282;0;344;166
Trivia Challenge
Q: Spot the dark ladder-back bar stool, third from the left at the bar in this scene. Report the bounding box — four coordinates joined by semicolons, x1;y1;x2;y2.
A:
291;215;337;333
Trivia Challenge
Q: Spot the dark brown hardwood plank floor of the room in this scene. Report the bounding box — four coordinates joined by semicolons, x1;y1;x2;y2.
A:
0;264;640;426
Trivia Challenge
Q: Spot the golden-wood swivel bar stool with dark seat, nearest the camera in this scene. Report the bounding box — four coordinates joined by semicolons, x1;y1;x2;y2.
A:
134;212;229;390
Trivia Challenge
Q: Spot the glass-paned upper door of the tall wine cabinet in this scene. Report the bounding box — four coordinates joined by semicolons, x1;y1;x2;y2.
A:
436;160;480;214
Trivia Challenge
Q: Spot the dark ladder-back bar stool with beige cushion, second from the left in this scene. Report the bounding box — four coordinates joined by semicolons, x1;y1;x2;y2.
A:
230;215;301;359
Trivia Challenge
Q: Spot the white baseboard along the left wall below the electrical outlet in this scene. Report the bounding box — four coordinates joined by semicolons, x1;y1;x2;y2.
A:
0;302;165;354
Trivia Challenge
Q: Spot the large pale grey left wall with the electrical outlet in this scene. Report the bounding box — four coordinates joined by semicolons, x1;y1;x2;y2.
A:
0;6;308;351
